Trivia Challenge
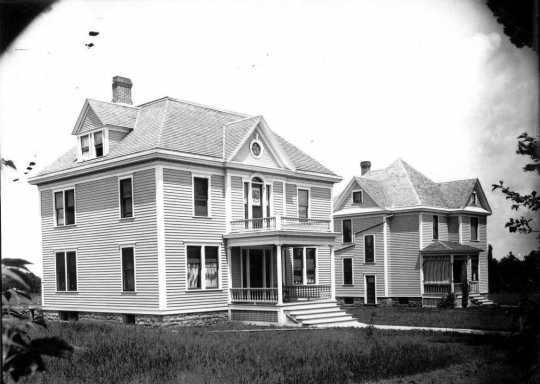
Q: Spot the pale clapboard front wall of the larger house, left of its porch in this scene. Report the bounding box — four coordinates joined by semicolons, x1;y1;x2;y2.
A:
163;168;229;310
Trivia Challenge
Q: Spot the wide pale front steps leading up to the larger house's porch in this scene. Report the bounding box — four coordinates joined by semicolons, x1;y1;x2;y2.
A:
286;302;358;328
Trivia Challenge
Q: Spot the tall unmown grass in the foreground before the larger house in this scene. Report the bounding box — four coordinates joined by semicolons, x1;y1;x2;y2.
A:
25;322;520;384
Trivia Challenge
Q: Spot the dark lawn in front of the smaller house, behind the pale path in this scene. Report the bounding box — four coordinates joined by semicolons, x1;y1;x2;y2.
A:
344;306;518;331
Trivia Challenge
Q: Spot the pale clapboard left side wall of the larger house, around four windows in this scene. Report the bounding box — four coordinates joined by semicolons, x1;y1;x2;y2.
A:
40;167;158;312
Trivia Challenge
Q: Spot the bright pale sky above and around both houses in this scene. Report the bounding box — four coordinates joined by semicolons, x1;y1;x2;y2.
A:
0;0;539;275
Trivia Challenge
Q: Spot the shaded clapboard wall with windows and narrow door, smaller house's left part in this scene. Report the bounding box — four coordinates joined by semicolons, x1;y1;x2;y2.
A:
334;216;384;297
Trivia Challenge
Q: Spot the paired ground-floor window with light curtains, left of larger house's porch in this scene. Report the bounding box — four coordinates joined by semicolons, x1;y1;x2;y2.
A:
186;245;219;290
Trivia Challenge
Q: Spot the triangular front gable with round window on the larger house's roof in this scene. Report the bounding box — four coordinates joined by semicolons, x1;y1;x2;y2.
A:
225;116;295;170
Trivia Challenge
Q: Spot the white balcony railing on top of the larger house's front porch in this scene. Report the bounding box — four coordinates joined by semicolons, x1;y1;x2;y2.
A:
227;216;330;233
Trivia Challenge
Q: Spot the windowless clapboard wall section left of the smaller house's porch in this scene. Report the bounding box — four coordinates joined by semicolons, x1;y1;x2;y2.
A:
388;214;420;297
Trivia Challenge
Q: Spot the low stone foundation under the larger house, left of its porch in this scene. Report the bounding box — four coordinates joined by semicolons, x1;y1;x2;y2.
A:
43;311;229;327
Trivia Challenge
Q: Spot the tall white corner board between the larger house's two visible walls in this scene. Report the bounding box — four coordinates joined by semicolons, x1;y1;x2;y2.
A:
155;166;167;309
